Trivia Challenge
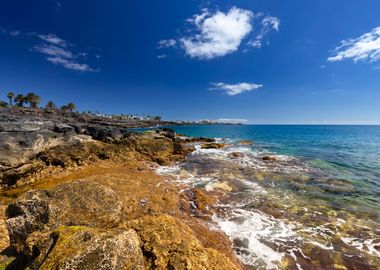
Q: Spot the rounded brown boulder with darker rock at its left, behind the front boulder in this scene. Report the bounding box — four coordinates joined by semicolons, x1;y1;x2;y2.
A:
6;180;123;252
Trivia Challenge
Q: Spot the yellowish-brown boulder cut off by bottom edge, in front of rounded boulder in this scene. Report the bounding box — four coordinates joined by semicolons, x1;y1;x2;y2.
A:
29;226;144;270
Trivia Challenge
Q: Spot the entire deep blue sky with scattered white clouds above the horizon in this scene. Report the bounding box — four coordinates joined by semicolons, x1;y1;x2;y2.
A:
0;0;380;124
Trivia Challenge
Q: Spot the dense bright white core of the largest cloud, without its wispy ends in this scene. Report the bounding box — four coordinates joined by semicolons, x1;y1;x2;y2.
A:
180;7;253;59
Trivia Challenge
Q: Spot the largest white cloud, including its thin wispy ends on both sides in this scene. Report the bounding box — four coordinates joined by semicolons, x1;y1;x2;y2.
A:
158;7;280;59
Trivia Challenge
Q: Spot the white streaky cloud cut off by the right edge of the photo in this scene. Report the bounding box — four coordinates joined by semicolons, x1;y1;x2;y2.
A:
327;26;380;62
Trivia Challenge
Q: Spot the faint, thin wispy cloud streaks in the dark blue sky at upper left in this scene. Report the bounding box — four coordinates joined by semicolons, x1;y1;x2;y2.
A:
1;29;100;72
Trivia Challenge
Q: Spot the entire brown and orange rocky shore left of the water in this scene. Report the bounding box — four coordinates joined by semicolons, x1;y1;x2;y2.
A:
0;109;242;269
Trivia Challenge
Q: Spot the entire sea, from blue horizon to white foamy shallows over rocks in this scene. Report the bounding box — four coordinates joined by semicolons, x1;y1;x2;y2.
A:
158;125;380;269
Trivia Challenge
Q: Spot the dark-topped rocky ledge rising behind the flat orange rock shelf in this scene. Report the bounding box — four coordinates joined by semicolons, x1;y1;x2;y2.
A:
0;114;195;188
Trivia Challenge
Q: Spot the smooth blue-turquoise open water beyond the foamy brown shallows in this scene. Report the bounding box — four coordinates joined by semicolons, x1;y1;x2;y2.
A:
172;125;380;204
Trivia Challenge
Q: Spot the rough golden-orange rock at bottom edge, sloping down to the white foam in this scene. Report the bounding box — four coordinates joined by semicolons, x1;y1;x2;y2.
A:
131;215;239;270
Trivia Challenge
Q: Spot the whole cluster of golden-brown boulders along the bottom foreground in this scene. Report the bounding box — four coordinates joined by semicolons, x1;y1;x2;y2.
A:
0;180;240;270
